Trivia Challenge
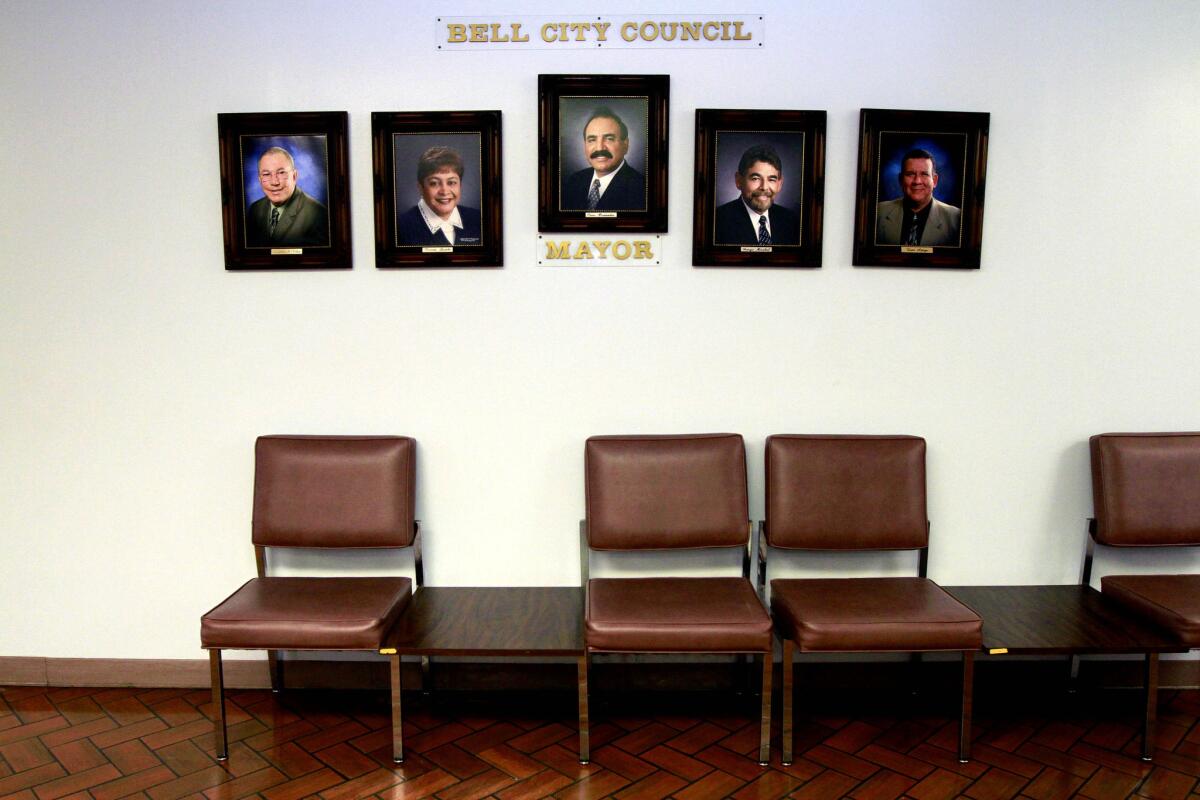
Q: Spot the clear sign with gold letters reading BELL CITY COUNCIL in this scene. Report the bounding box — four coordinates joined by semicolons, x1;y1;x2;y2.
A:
433;14;767;50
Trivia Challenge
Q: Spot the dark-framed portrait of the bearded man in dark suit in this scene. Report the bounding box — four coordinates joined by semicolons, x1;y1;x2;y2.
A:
691;108;826;267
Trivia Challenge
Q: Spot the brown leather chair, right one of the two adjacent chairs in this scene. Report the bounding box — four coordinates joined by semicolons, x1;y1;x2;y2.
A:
758;435;983;764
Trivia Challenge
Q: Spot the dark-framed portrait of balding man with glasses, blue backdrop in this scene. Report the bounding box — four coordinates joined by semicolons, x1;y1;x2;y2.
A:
217;112;353;270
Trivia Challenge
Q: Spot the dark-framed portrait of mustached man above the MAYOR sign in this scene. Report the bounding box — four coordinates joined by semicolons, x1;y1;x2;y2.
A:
538;76;671;233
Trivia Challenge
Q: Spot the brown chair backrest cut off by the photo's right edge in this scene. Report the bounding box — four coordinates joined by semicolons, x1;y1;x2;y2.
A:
1090;433;1200;547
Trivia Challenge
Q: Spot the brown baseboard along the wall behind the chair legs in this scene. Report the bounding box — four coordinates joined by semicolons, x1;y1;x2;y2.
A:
0;656;1200;691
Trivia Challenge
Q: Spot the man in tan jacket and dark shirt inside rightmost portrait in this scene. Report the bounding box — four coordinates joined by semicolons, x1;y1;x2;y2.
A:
875;148;962;247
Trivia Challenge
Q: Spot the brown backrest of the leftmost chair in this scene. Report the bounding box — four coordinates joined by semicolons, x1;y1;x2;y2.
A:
253;437;416;547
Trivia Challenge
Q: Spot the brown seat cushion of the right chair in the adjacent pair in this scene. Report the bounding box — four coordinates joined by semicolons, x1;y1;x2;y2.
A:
770;578;983;652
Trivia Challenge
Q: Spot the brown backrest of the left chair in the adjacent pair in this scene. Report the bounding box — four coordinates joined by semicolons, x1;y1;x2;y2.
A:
584;433;750;551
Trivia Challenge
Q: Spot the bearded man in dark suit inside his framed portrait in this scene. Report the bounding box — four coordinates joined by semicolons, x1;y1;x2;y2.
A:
713;144;800;247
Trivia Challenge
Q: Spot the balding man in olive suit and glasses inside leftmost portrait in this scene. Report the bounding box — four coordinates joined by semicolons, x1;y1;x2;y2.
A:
246;148;329;247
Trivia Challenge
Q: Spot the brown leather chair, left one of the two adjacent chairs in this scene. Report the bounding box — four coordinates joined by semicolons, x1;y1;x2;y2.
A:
578;433;773;764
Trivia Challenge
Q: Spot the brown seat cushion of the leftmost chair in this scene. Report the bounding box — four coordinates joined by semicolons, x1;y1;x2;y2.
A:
200;577;413;650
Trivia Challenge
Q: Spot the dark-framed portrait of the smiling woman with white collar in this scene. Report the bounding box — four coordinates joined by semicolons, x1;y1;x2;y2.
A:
371;112;504;269
